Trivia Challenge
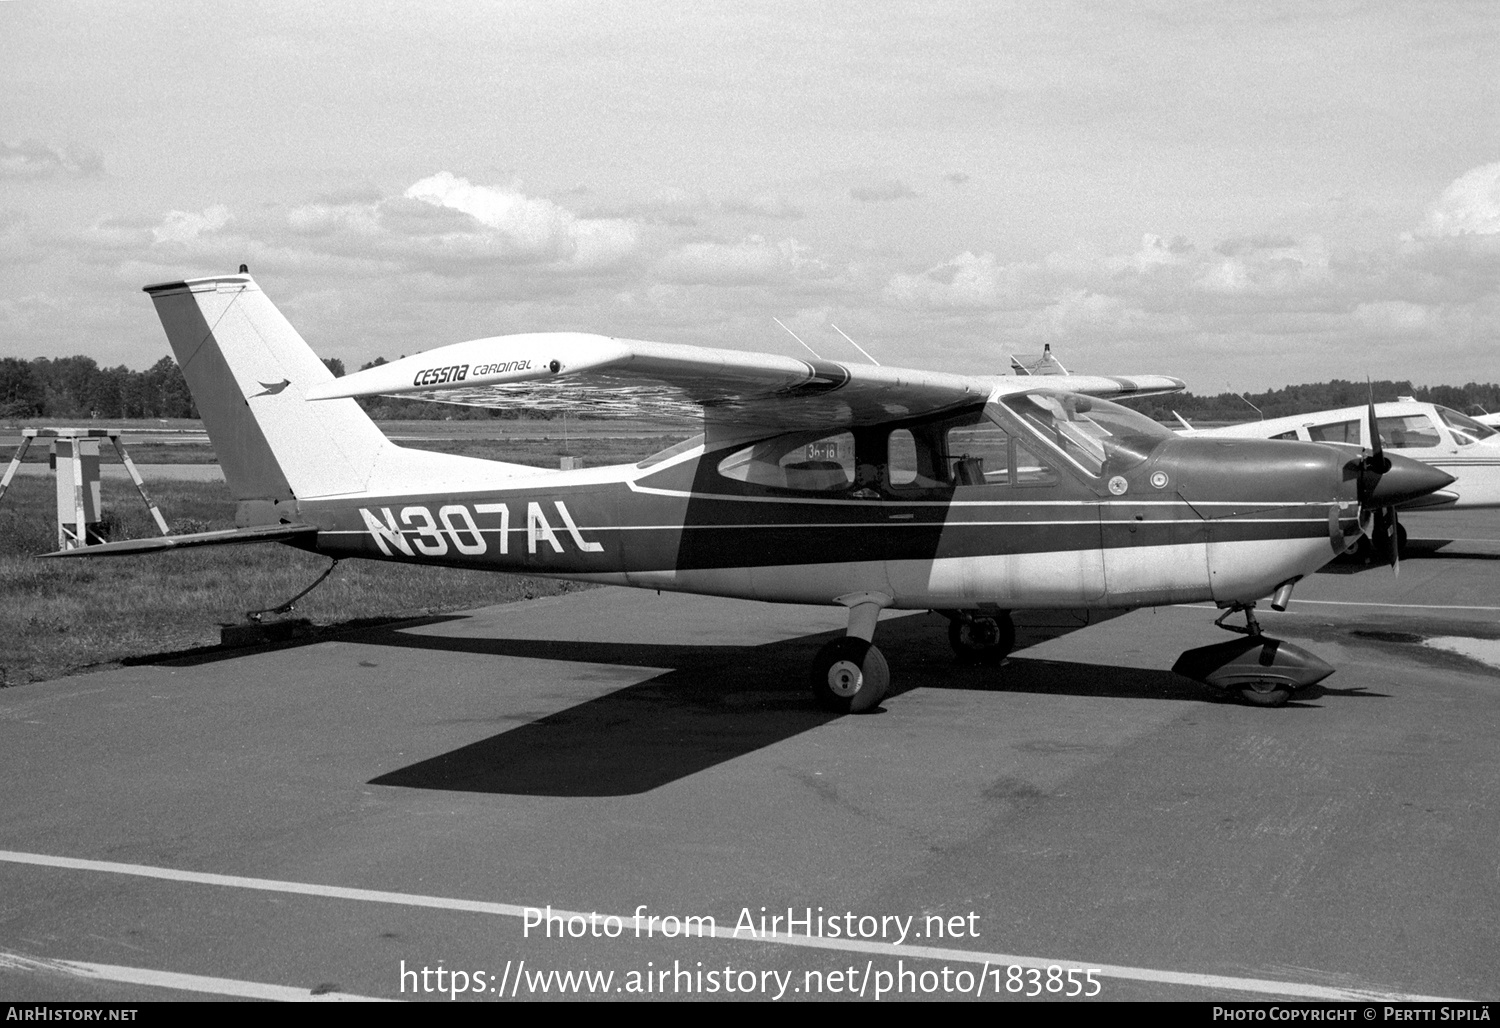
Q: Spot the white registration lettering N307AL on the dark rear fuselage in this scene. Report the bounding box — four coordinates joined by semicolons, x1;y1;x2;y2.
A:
360;500;605;557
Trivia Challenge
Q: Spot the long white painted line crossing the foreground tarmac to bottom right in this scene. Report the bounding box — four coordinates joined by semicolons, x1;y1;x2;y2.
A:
0;849;1466;1002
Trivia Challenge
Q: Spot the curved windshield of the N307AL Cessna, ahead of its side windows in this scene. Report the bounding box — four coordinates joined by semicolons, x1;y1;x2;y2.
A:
999;392;1173;474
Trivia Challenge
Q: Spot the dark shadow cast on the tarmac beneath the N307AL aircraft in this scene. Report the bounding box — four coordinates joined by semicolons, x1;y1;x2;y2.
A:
132;611;1359;797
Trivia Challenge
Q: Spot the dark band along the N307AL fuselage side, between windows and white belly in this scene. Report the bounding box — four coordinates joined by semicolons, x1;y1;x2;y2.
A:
308;485;1353;573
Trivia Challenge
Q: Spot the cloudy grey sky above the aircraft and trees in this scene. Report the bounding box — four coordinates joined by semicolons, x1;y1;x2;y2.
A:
0;0;1500;392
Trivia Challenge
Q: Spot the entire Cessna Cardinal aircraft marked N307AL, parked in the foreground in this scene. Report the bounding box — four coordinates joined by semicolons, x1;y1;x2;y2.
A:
43;269;1451;711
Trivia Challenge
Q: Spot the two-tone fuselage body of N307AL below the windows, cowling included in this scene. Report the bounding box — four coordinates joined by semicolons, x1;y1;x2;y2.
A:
299;440;1359;609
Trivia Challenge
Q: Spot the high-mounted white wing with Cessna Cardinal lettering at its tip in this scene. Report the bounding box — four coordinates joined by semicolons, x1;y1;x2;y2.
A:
308;332;1184;431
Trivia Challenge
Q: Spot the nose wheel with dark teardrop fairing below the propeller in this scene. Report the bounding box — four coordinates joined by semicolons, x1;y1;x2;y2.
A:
1172;603;1334;707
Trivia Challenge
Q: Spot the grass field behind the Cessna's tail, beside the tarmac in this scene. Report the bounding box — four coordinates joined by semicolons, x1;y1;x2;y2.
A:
0;420;702;686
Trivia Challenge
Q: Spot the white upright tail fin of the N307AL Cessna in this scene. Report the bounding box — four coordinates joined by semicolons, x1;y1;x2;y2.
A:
146;275;395;503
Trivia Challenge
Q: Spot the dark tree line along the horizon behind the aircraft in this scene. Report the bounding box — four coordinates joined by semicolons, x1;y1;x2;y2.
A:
0;356;1500;423
